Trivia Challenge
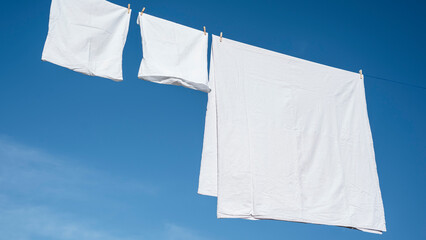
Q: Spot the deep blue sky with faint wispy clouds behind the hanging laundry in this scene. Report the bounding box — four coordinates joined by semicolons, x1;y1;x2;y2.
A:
0;0;426;240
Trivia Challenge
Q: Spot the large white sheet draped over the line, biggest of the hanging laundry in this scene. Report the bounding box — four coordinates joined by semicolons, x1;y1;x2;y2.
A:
198;36;386;233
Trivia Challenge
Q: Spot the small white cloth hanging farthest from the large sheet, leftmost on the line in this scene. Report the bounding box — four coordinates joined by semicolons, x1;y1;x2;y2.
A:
42;0;130;81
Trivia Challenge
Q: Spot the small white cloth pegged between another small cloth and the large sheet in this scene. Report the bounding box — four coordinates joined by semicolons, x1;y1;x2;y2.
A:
138;13;210;92
